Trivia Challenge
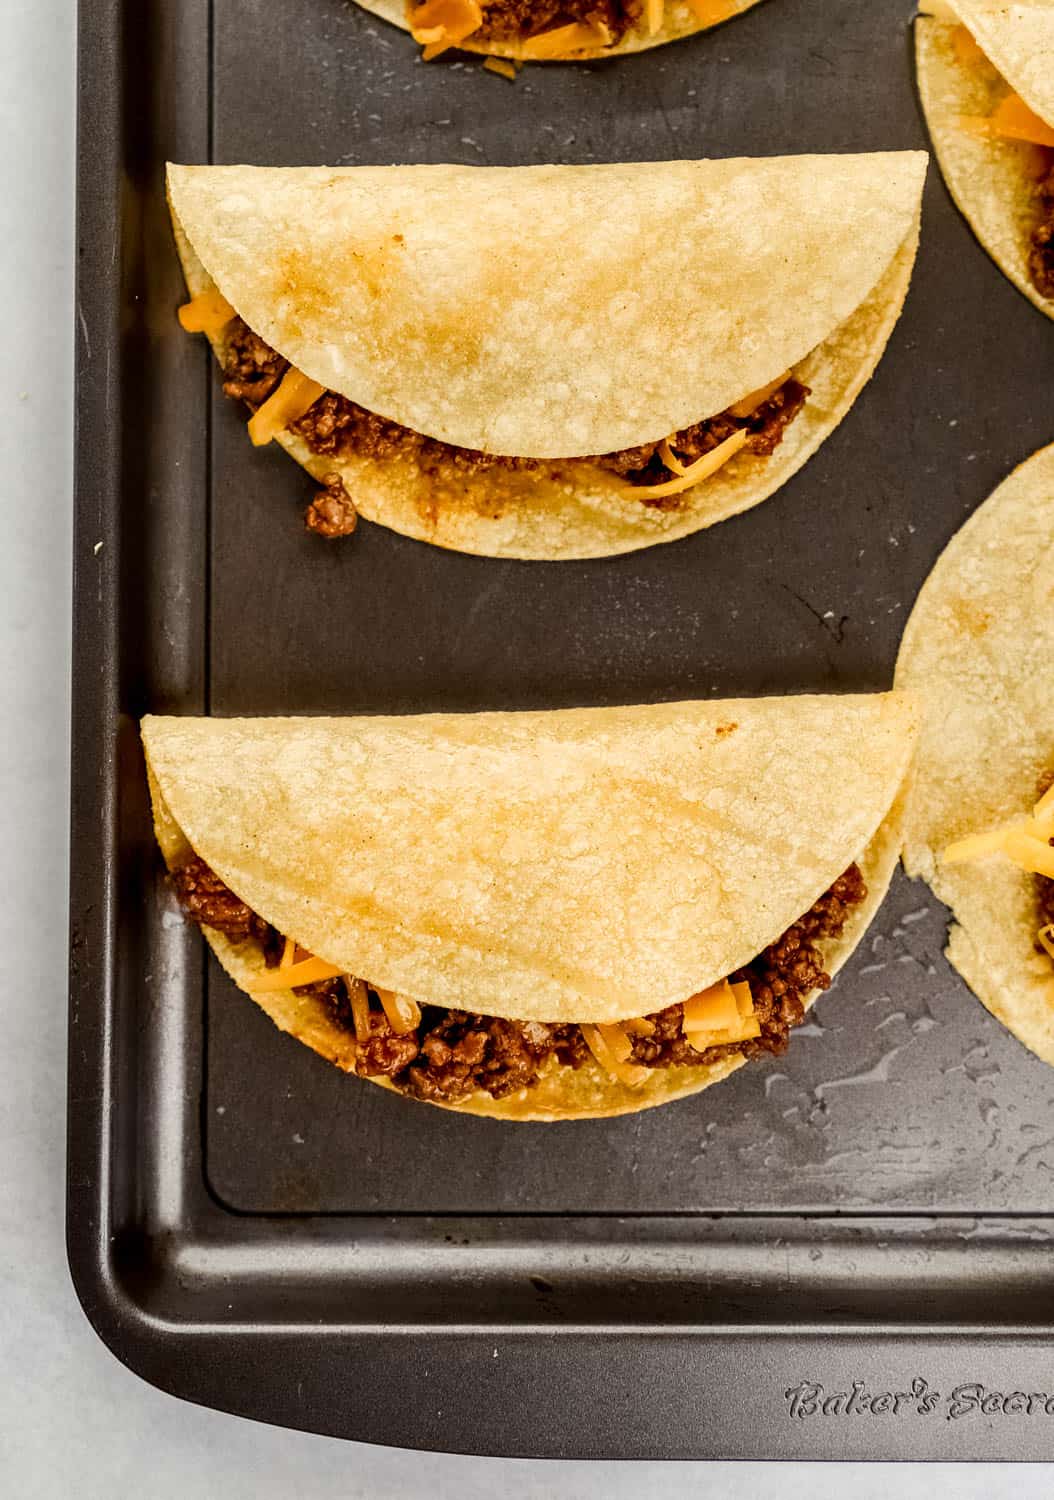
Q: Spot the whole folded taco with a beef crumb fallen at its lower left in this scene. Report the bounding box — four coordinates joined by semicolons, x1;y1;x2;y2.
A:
168;152;927;560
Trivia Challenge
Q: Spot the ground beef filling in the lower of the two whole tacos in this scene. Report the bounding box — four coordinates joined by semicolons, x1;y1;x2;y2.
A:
172;855;863;1100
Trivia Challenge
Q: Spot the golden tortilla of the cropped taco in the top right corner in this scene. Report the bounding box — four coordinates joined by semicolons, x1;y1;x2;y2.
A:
915;0;1054;318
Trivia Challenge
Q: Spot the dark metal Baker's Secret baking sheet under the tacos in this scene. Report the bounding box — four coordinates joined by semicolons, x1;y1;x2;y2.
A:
69;0;1054;1458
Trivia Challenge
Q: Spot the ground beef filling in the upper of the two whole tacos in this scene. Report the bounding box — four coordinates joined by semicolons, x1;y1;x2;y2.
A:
223;318;810;501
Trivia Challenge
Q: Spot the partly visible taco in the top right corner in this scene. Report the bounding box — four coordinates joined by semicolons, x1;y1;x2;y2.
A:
915;0;1054;318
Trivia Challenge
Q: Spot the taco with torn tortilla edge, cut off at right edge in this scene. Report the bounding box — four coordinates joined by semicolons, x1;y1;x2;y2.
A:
897;446;1054;1062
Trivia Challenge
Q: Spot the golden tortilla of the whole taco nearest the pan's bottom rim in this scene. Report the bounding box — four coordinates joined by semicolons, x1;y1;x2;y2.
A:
142;695;915;1119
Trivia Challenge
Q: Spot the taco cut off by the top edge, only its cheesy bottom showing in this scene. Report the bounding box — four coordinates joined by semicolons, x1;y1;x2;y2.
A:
358;0;757;63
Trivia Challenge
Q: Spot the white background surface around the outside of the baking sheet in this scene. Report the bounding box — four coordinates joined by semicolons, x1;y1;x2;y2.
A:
0;0;1054;1500
